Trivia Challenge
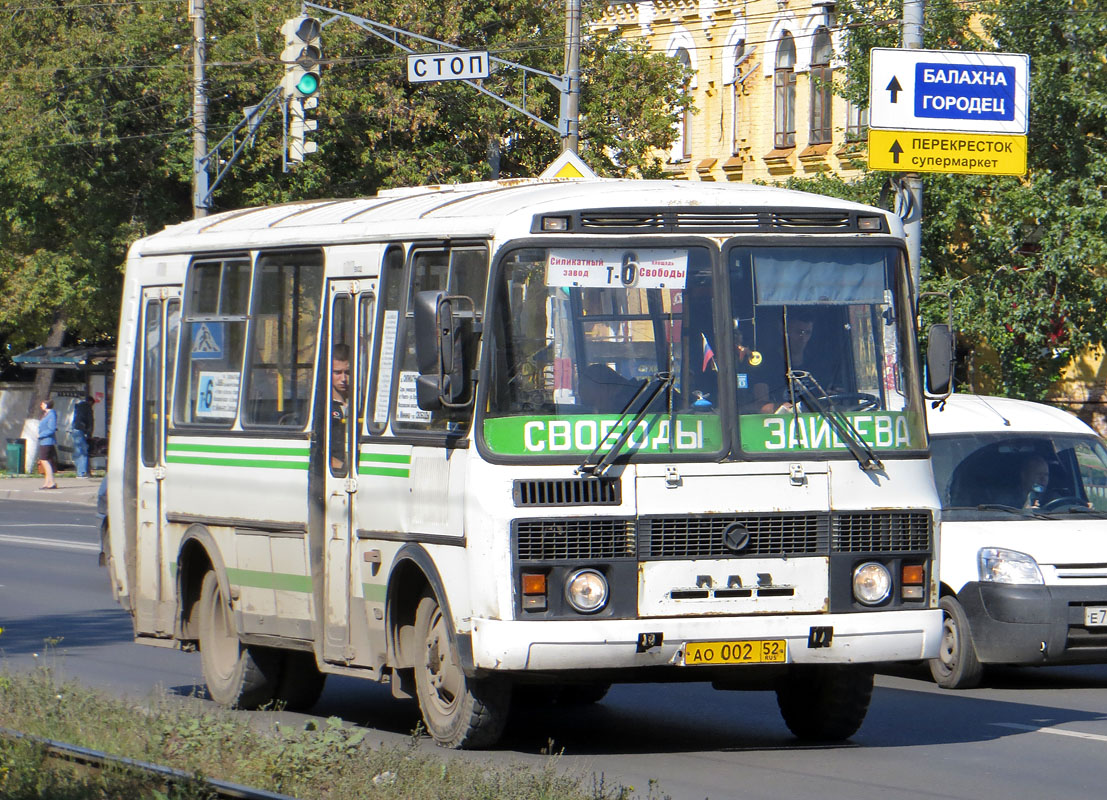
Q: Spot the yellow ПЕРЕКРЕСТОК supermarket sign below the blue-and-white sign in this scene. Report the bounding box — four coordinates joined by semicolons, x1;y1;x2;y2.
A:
869;128;1026;175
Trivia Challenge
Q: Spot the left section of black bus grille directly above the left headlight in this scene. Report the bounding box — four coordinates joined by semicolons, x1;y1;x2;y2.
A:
514;517;634;561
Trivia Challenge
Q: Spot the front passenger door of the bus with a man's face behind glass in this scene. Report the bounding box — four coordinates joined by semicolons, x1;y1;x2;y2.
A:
319;280;373;663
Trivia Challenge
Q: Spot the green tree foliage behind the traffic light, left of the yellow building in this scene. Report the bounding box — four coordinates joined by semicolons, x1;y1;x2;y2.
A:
0;0;687;362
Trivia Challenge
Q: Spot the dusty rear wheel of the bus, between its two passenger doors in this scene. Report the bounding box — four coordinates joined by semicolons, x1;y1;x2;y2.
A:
197;570;280;708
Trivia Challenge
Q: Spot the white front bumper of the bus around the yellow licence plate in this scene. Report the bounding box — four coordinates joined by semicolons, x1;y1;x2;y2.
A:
466;610;942;672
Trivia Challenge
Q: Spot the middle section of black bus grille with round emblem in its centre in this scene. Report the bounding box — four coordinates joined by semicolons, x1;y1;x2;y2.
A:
639;515;829;559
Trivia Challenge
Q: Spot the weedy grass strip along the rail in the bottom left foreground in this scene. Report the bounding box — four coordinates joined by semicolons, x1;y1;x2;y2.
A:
0;667;660;800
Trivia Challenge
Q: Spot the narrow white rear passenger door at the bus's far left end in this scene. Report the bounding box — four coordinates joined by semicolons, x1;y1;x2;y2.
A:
135;287;180;634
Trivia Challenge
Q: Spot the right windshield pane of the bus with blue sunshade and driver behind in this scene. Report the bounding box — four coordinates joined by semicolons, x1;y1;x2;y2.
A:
727;245;925;457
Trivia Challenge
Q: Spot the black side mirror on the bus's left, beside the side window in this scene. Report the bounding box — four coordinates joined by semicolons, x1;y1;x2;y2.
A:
415;291;473;411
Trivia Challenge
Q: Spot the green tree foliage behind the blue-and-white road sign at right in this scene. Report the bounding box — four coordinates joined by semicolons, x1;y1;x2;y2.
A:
811;0;1107;398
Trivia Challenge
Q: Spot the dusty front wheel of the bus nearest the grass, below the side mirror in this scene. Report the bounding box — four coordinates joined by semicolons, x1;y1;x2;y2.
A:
415;594;511;749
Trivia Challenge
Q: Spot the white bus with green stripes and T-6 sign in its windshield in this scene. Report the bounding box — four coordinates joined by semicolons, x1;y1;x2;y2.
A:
107;180;942;747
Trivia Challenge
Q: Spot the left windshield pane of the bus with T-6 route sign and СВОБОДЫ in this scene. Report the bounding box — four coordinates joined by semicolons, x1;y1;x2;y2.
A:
483;243;723;457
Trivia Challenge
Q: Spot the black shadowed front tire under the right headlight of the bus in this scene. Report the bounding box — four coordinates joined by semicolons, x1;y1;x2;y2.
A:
776;664;872;741
